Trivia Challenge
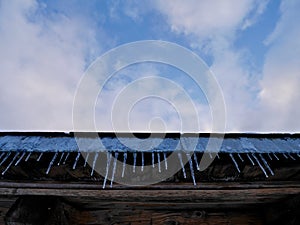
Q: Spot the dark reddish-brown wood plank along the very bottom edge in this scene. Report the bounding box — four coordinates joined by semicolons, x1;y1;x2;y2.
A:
72;209;263;225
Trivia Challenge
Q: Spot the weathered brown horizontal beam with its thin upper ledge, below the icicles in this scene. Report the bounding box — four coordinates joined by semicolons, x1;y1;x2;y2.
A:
0;183;300;205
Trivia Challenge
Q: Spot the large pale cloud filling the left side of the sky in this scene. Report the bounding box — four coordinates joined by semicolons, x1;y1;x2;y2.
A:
0;0;96;130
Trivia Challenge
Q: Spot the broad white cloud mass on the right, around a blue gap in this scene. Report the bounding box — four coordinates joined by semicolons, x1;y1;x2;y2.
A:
152;0;300;132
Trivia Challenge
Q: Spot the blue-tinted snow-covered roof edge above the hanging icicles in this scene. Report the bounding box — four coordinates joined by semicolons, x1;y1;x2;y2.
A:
0;132;300;153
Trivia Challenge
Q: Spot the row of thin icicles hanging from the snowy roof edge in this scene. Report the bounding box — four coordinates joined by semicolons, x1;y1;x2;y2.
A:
0;152;300;189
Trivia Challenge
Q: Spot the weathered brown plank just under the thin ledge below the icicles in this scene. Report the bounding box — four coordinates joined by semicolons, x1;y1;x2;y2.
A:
0;188;300;205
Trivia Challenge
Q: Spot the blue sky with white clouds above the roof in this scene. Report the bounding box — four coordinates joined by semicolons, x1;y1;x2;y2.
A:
0;0;300;133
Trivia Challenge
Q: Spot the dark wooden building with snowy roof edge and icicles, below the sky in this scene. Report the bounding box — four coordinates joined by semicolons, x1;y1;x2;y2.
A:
0;132;300;225
